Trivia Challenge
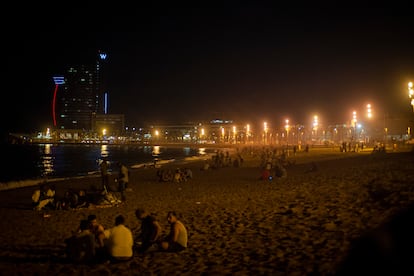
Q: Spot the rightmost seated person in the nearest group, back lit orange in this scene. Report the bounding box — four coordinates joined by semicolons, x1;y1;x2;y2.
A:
161;211;188;252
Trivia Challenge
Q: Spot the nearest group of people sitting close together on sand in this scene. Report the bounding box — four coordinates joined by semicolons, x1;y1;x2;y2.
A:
65;209;188;264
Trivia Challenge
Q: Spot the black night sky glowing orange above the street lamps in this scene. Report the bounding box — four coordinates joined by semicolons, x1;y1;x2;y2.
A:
1;1;414;135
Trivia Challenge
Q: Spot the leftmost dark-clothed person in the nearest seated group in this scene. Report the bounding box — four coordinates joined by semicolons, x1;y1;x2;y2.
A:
65;220;96;263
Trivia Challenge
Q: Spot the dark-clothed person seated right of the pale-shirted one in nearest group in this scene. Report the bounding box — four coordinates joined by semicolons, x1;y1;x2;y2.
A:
135;209;162;253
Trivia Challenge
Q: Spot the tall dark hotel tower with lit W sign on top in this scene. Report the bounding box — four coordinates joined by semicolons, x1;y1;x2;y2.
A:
52;52;107;132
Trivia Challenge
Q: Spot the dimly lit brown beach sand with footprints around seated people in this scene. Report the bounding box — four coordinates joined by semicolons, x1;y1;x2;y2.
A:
0;148;414;275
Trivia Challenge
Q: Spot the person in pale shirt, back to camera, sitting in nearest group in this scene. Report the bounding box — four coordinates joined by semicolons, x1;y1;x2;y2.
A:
105;215;134;262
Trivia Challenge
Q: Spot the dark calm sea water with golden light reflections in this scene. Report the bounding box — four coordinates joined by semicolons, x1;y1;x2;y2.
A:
0;144;215;183
